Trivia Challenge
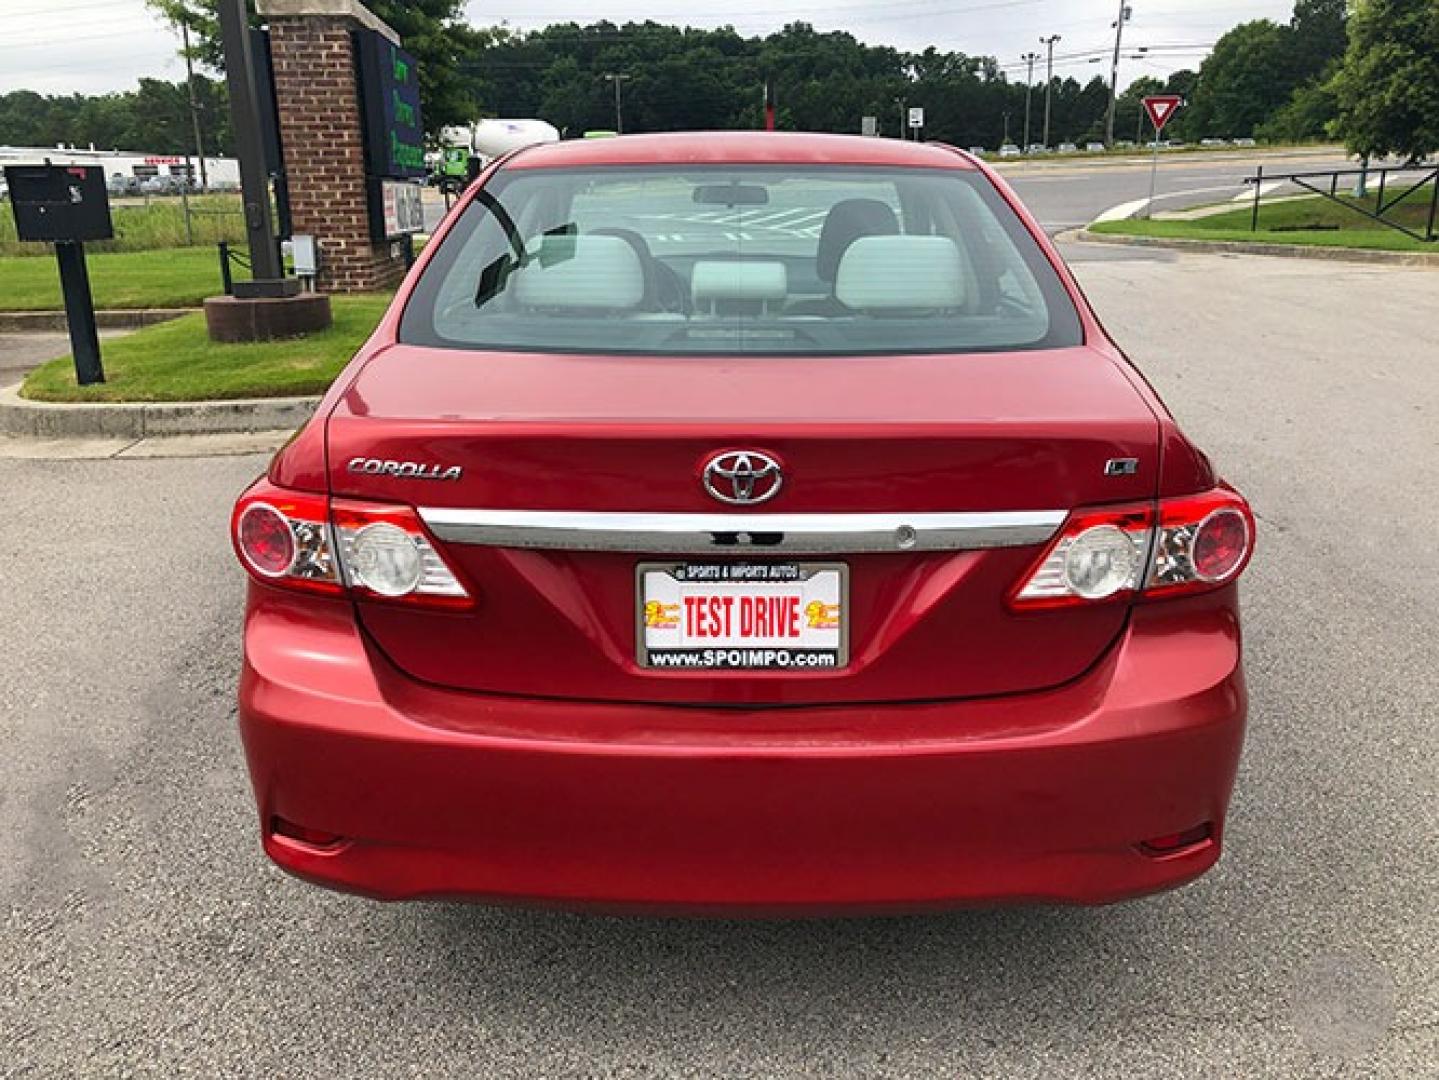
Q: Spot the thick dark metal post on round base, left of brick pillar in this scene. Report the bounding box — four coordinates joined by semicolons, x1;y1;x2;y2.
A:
219;0;291;287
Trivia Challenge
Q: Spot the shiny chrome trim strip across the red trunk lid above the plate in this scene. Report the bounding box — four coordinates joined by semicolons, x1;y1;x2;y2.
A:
420;508;1068;555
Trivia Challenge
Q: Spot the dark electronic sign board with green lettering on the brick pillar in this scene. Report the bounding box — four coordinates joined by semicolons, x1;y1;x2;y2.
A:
354;30;426;180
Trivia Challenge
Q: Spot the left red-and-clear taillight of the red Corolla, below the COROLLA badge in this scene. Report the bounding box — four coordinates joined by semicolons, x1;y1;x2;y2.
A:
230;480;471;607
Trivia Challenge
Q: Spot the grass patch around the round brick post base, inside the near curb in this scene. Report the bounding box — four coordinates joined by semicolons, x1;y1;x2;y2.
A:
20;295;390;401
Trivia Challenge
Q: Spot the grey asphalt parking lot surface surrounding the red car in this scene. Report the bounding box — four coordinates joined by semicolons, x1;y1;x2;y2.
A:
0;247;1439;1077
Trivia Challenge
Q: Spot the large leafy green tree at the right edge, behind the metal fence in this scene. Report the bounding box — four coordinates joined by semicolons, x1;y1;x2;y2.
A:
1333;0;1439;160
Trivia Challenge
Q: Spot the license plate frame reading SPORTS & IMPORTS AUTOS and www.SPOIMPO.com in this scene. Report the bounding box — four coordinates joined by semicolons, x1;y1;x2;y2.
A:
633;558;850;674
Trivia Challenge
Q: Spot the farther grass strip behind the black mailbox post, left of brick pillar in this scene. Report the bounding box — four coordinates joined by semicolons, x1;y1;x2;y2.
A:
0;247;249;311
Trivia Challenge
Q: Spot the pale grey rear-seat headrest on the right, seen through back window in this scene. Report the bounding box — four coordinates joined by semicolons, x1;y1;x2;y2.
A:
835;236;964;311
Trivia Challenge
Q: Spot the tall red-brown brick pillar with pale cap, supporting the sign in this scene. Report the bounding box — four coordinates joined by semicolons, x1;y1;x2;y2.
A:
256;0;404;292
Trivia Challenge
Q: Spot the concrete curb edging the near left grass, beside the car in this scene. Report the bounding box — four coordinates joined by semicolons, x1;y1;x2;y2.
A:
0;384;319;439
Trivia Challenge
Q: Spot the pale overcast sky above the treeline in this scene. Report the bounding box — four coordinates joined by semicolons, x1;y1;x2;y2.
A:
0;0;1292;93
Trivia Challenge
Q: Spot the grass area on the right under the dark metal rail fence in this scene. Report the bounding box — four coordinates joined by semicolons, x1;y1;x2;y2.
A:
1091;187;1439;255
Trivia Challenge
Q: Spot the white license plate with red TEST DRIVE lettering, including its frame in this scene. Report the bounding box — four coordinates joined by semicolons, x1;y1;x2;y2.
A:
637;562;849;672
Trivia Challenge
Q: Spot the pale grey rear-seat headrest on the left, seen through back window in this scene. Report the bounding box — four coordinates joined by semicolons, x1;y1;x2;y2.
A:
515;236;645;311
